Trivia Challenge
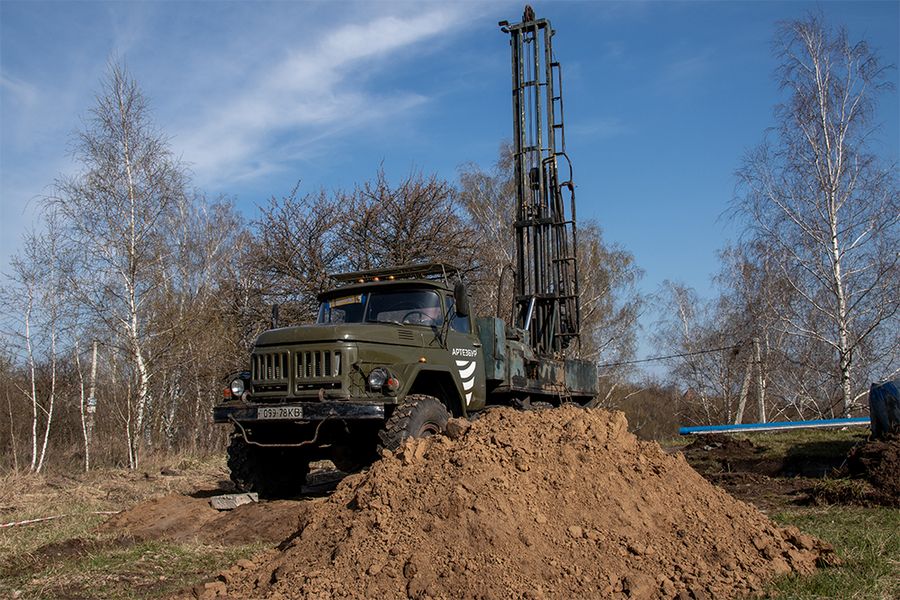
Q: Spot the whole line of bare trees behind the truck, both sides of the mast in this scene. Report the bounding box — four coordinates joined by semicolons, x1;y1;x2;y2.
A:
0;16;900;471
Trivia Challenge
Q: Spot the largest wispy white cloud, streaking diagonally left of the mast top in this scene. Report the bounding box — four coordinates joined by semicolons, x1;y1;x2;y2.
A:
173;5;462;184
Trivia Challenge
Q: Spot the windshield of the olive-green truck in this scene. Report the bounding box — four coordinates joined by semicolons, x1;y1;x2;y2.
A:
318;290;444;327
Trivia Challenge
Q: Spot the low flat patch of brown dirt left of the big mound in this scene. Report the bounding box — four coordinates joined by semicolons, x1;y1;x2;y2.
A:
100;494;306;545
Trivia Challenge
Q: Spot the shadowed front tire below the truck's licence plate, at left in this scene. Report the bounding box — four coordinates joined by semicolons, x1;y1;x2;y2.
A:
228;434;309;498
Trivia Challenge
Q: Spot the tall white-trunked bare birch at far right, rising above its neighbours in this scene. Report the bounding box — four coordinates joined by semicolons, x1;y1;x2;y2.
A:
736;16;900;415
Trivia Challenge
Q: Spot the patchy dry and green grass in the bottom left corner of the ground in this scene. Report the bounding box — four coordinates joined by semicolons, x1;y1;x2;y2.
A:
0;459;267;600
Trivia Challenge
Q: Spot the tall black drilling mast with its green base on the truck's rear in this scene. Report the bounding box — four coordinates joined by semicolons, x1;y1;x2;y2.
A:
479;6;597;403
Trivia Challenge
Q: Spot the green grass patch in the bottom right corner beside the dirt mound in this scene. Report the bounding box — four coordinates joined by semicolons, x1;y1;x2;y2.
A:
771;506;900;600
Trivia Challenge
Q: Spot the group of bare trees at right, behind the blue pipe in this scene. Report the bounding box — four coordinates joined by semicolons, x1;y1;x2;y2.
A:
655;15;900;423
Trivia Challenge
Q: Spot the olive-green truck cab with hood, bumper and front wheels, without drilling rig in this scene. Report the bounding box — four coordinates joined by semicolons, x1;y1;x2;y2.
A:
213;264;486;492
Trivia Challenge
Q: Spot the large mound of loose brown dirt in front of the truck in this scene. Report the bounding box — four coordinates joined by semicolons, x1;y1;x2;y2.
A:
197;407;833;599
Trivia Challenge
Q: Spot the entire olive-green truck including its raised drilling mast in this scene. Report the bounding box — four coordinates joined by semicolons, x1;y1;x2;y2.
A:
213;7;597;495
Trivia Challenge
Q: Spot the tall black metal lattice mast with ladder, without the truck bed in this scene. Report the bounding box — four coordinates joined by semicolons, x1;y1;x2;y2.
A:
500;7;581;356
